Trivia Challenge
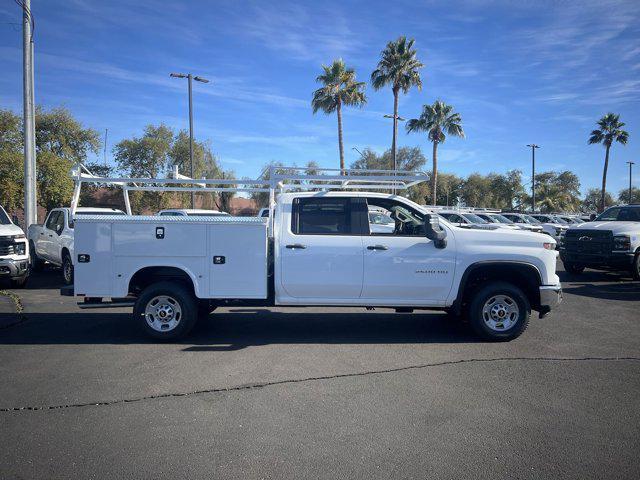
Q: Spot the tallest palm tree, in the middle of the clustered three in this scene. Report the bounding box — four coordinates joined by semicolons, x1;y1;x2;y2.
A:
371;36;424;170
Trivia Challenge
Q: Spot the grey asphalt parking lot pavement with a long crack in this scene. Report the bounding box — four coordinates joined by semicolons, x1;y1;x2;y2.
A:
0;266;640;479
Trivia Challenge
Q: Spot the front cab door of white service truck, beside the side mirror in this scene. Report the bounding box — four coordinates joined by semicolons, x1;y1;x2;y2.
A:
362;198;456;306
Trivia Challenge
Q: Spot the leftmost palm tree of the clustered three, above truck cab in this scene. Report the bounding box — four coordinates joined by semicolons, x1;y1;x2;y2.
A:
311;58;367;173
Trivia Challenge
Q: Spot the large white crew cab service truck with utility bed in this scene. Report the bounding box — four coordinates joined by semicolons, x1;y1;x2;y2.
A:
61;189;562;341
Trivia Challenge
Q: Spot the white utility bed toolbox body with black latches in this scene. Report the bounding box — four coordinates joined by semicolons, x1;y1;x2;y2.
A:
73;215;267;299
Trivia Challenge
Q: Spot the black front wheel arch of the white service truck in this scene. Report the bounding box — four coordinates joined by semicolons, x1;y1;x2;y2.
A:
453;260;542;314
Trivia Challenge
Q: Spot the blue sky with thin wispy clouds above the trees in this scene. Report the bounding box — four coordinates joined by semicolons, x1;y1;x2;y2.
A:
0;0;640;193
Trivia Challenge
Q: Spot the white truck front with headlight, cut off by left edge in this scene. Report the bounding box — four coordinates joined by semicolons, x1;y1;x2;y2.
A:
0;205;29;288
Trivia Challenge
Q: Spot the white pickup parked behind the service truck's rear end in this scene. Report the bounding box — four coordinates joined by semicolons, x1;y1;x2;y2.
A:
28;207;125;285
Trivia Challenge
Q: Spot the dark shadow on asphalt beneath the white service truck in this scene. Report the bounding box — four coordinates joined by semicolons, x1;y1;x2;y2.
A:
0;309;478;351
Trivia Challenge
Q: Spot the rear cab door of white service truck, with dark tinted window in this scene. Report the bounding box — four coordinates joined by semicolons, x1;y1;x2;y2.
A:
278;196;364;298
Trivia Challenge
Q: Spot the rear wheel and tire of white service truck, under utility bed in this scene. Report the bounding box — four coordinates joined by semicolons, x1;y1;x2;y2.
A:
133;282;198;342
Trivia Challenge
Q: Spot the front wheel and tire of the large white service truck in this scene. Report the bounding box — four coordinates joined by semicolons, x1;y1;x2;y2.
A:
468;282;531;342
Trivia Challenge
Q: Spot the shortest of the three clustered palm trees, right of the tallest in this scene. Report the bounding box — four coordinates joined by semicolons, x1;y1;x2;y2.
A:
407;100;464;205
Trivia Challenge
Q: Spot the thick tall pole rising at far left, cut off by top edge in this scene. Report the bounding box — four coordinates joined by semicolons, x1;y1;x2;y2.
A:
21;0;38;230
